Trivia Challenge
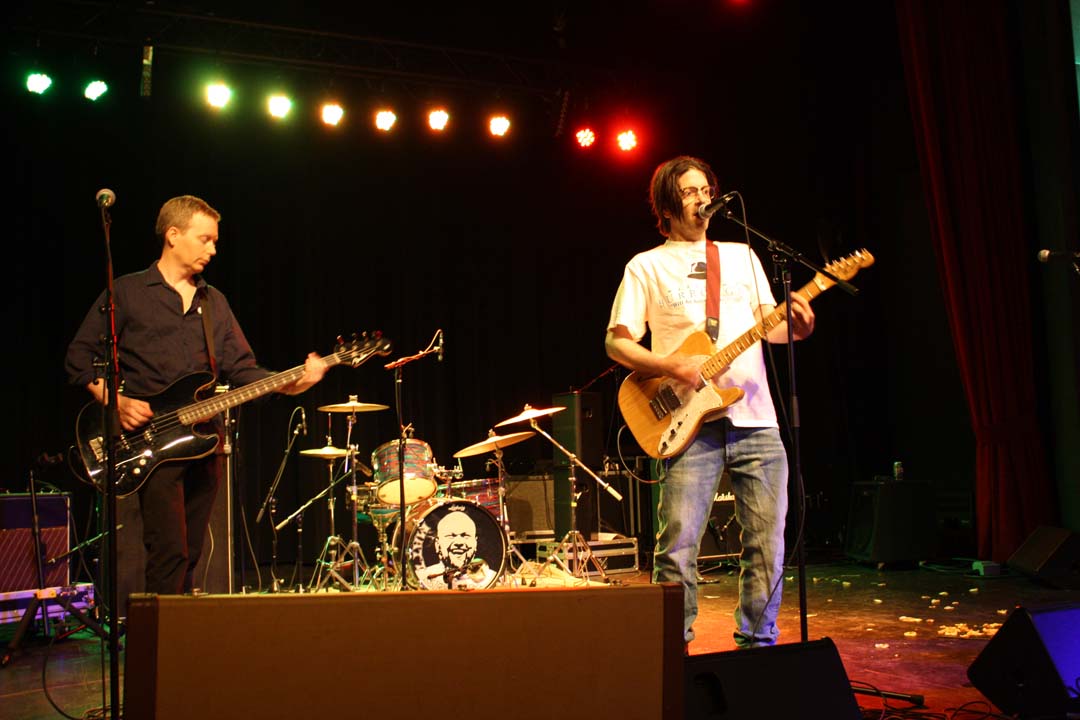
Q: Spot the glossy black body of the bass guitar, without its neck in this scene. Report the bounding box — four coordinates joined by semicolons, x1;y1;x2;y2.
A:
76;372;218;498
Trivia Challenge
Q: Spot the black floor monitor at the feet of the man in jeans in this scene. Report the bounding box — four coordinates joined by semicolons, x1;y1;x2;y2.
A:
684;638;862;720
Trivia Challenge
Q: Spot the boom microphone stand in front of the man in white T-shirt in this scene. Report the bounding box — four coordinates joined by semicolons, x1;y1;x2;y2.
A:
720;207;859;642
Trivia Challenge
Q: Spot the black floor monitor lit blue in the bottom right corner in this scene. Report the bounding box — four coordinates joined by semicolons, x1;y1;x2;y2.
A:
968;602;1080;719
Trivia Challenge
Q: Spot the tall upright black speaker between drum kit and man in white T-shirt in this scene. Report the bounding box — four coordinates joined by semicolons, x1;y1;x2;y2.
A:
551;392;605;540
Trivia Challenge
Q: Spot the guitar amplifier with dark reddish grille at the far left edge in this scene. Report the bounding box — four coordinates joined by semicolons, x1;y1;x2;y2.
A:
0;492;71;593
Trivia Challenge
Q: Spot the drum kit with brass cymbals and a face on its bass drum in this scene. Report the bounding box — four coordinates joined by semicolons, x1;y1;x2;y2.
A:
275;396;583;592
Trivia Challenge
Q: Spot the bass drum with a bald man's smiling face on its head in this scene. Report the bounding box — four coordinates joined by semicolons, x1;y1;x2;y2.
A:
394;498;509;590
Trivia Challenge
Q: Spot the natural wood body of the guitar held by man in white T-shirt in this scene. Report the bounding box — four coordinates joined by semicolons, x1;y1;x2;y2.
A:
619;332;745;459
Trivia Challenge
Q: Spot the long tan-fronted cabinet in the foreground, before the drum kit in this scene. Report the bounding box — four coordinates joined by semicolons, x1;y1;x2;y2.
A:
124;583;682;720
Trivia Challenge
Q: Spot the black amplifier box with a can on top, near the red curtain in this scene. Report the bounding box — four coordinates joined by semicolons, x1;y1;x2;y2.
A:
843;480;937;562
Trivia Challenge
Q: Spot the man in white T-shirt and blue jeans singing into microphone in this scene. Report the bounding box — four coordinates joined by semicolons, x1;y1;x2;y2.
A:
605;155;814;652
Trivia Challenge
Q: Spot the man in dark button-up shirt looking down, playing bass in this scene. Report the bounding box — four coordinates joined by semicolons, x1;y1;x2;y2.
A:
66;195;326;595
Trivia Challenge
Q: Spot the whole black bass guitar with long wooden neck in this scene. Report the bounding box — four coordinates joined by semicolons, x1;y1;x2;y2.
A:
76;332;391;498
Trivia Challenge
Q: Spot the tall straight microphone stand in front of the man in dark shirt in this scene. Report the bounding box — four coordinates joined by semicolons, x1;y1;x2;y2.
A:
100;198;121;718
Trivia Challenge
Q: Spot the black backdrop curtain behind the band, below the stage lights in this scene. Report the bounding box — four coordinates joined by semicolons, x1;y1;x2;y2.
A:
6;3;993;578
